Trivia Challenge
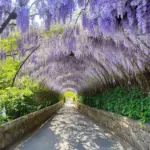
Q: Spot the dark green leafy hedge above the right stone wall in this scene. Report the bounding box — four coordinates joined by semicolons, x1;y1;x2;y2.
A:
79;87;150;122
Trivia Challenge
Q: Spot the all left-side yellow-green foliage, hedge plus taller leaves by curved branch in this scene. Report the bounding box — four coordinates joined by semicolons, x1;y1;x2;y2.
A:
0;58;60;124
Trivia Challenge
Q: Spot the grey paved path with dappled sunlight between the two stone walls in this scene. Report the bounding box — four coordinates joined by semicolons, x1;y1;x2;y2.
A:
12;102;134;150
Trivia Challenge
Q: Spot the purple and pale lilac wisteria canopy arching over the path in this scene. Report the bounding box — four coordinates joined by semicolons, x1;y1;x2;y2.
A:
0;0;150;92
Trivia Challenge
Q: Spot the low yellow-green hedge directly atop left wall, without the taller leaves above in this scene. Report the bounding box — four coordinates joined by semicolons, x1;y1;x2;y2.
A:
0;87;60;124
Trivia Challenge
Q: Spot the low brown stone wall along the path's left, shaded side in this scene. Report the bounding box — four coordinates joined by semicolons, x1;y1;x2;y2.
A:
0;101;64;150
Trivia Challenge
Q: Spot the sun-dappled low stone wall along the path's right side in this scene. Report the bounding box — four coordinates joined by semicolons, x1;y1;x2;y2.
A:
75;103;150;150
